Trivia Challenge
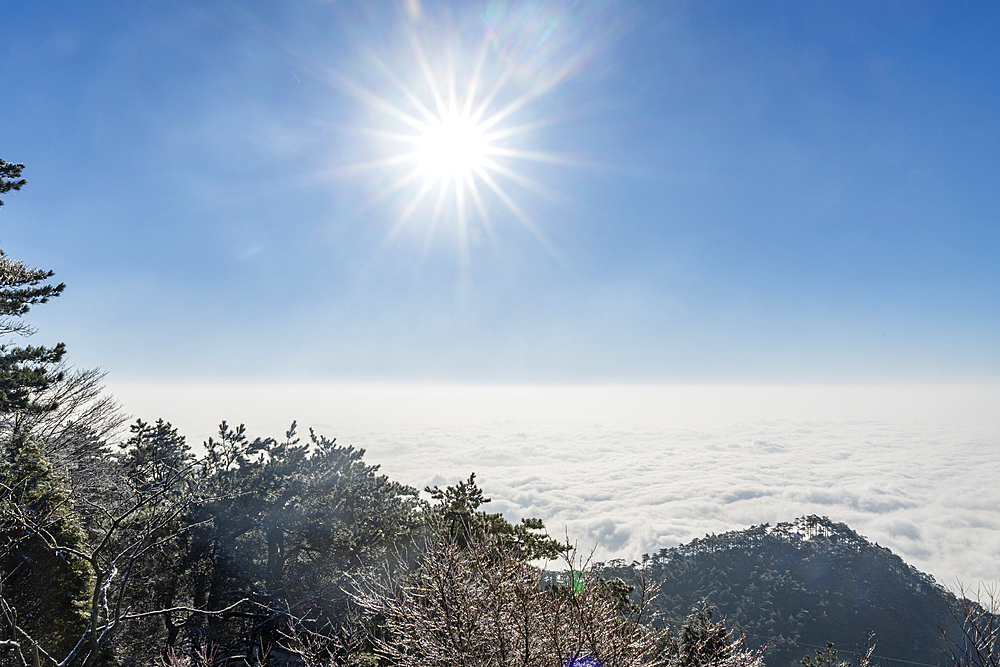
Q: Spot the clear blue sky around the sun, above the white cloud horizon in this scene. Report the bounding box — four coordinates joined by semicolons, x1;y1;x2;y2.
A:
0;0;1000;383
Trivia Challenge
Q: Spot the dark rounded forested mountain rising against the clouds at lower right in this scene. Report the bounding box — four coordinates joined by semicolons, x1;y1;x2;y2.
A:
603;516;958;667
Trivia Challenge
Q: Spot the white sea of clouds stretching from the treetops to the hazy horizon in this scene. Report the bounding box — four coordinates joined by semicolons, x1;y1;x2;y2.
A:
115;385;1000;587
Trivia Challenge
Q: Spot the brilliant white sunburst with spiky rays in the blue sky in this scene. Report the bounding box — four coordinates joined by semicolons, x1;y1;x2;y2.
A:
340;13;578;264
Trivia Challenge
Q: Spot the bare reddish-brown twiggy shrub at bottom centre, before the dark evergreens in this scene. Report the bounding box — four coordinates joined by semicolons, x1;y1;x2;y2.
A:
355;538;662;667
